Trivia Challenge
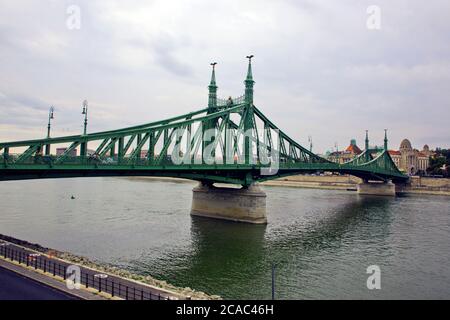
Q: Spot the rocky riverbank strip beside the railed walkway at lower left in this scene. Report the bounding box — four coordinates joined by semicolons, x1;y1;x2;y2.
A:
0;234;220;300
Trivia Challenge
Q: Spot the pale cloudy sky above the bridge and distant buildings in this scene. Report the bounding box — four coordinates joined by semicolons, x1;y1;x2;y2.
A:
0;0;450;152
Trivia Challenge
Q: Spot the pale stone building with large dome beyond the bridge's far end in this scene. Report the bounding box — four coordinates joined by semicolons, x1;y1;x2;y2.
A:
389;139;433;175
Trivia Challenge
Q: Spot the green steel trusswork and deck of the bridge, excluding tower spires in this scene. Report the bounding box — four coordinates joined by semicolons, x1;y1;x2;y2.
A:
0;97;407;185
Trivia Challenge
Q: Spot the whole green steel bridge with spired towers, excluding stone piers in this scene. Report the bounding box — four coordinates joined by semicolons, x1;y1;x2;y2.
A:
0;56;408;186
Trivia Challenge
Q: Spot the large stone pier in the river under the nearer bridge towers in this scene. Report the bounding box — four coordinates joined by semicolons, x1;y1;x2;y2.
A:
191;183;267;224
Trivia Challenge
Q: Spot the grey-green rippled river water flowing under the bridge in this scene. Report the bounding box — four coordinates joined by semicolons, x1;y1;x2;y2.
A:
0;178;450;299
